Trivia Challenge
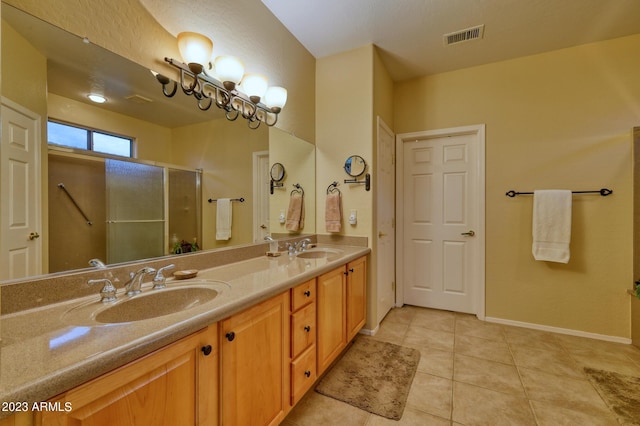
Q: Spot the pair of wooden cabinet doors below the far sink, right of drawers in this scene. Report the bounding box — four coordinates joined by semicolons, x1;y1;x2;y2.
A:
317;257;367;375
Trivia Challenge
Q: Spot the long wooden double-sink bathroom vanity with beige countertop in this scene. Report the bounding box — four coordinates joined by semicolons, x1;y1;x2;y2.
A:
0;246;370;426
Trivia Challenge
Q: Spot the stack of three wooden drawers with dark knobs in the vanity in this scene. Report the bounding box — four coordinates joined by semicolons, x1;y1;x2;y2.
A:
290;278;317;406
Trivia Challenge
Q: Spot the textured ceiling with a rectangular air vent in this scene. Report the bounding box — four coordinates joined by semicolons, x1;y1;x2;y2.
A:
262;0;640;80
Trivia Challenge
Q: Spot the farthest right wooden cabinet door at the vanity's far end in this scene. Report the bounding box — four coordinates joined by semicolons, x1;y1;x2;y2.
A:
347;257;367;341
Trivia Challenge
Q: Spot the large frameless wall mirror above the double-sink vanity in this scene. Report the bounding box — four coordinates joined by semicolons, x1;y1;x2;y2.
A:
0;3;315;280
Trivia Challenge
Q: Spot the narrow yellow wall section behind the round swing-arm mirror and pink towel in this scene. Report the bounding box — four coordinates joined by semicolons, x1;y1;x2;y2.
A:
316;45;374;241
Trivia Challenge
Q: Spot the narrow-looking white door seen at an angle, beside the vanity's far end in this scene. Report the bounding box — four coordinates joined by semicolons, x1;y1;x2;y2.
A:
375;118;396;324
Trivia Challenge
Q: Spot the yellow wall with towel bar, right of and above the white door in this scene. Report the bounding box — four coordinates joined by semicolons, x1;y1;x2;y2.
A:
394;35;640;338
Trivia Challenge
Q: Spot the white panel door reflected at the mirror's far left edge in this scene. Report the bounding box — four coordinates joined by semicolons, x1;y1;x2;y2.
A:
0;99;42;280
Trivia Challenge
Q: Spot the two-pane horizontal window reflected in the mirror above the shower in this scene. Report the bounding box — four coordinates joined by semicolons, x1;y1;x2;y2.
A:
47;121;133;157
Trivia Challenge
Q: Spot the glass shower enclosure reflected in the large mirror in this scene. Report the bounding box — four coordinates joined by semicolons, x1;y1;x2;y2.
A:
49;153;202;272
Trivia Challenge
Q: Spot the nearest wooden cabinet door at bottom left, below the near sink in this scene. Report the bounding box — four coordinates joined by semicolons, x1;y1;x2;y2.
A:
36;326;218;426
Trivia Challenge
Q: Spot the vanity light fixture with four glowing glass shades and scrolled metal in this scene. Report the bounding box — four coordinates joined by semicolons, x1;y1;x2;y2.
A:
152;32;287;129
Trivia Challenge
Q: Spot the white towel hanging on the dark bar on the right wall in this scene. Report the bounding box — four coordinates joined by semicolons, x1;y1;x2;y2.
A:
532;189;572;263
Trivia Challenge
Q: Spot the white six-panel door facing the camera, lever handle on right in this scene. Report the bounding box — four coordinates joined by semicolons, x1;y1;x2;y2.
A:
402;133;481;313
